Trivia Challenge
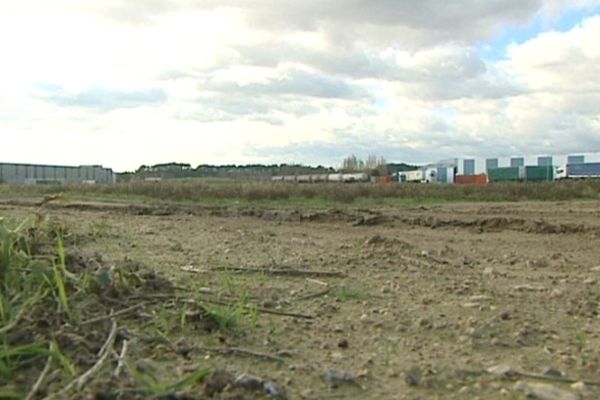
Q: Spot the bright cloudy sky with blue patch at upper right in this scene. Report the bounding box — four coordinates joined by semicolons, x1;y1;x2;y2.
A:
0;0;600;171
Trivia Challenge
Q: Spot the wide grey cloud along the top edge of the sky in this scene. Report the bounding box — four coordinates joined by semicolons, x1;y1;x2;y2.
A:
97;0;552;47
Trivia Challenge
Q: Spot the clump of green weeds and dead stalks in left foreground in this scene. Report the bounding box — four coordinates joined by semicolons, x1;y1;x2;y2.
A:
0;212;208;398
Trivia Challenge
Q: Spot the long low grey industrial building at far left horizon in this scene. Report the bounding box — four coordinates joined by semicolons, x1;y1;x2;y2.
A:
0;163;116;185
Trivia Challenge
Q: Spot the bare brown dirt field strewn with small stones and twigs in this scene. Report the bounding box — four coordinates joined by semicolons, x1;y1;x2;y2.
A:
0;201;600;400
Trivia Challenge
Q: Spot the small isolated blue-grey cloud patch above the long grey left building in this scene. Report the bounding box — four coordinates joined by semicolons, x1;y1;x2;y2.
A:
36;84;167;111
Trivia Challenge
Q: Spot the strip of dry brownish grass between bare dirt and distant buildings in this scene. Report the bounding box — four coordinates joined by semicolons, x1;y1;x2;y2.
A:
0;179;600;206
